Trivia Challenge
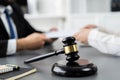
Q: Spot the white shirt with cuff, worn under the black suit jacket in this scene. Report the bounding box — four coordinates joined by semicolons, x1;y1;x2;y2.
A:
1;6;18;55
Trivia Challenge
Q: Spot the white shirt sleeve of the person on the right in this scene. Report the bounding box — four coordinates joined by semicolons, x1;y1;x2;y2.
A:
88;29;120;56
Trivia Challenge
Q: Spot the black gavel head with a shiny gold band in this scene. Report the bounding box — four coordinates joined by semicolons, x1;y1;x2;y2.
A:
62;37;79;62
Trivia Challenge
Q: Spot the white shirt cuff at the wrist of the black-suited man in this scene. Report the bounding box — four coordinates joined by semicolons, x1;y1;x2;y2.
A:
7;39;17;55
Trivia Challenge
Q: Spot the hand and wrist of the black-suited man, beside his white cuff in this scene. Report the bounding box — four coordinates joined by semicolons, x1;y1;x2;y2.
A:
17;33;46;50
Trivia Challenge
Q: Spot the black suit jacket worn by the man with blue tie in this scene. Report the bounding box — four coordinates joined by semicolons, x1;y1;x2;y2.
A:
0;3;43;57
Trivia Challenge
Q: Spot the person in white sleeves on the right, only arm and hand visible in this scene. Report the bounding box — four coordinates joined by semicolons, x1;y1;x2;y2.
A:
74;25;120;56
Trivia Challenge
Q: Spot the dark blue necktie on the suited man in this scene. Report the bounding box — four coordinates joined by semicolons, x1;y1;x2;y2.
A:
4;9;15;39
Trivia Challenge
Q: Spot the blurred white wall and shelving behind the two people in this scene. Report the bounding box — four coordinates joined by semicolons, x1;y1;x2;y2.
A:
17;0;120;31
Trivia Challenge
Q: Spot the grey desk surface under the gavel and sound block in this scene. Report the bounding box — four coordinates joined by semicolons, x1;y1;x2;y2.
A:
0;41;120;80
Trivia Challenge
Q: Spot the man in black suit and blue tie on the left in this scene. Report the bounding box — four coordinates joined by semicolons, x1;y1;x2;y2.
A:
0;0;56;57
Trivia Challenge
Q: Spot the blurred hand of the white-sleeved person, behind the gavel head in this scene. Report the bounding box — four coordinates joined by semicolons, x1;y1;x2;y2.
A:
74;28;91;44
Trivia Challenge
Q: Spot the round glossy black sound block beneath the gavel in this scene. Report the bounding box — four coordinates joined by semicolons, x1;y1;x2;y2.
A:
52;59;97;77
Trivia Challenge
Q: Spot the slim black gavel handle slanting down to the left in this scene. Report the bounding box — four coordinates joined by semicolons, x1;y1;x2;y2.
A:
24;49;64;63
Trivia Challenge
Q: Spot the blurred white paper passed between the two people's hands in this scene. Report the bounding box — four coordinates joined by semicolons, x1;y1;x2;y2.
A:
45;30;76;38
